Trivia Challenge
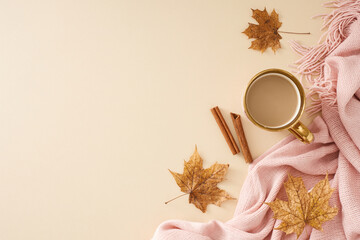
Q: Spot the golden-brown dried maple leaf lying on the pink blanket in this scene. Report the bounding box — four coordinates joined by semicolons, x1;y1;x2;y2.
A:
266;174;338;238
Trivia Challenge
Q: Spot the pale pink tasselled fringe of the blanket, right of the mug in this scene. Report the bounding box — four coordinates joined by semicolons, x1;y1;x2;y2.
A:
290;0;360;115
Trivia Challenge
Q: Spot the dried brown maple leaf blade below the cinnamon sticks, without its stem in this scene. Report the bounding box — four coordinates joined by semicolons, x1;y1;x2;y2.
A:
169;146;234;212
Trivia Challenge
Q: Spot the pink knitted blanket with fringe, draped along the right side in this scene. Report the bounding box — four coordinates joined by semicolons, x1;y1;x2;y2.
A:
153;0;360;240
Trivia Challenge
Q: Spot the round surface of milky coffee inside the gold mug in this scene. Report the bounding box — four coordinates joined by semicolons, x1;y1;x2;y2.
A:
246;73;300;128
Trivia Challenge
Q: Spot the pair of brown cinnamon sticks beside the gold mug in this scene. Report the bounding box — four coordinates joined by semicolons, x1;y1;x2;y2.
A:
211;106;253;163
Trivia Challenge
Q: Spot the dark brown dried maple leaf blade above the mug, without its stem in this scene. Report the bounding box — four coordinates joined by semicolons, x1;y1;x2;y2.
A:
243;8;282;53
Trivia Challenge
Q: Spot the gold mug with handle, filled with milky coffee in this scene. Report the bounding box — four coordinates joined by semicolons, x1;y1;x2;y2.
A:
244;68;314;143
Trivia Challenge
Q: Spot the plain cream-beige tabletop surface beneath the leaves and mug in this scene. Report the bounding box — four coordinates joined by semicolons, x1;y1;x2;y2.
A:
0;0;328;240
